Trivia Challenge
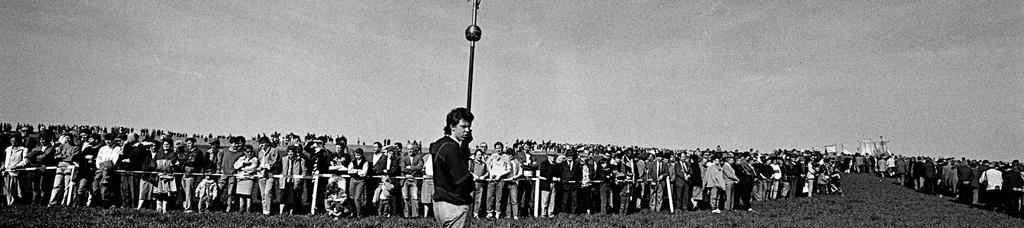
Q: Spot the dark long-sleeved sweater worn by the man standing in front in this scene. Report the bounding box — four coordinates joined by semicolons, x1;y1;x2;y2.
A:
430;136;473;206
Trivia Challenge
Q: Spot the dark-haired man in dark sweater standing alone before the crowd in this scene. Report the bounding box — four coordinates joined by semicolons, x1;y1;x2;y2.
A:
430;107;473;227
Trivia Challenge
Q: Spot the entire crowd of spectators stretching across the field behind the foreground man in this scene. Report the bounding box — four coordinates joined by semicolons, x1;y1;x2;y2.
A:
0;124;1021;219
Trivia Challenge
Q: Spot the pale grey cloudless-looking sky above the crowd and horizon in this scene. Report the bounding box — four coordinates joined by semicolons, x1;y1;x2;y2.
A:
0;0;1024;161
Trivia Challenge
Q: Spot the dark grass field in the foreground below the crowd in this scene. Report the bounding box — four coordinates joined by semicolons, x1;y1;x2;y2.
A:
0;175;1024;227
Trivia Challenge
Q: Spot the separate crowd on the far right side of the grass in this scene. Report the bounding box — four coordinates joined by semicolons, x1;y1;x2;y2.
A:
848;155;1024;217
